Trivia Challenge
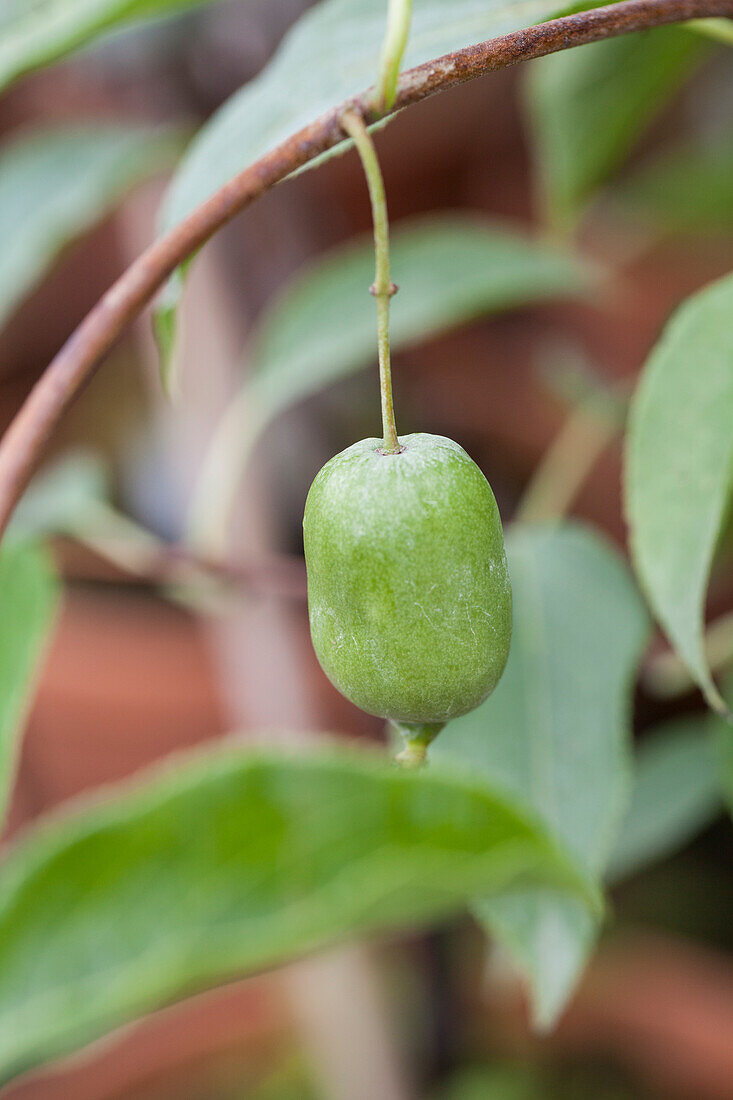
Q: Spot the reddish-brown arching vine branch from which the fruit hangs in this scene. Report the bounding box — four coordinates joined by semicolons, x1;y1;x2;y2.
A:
0;0;733;536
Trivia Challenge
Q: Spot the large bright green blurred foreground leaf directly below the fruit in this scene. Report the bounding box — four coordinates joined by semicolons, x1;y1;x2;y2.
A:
0;746;595;1081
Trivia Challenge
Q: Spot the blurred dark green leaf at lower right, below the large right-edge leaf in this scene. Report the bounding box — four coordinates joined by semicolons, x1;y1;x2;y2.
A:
609;716;721;879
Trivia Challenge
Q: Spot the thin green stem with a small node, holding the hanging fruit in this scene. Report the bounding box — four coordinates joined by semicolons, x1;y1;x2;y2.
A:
341;111;401;454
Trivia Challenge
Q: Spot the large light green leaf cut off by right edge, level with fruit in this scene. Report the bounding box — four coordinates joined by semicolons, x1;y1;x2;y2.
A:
625;275;733;713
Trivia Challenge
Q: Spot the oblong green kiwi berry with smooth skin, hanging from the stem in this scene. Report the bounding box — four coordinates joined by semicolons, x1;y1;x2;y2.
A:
303;435;512;724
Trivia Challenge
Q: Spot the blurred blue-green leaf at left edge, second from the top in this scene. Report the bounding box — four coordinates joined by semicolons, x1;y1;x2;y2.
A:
0;123;182;326
